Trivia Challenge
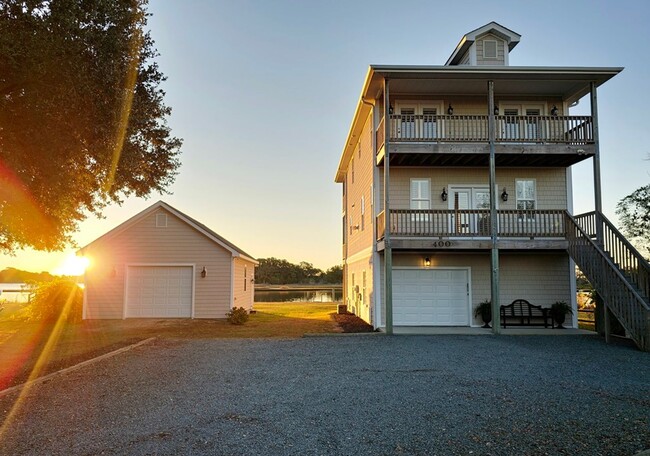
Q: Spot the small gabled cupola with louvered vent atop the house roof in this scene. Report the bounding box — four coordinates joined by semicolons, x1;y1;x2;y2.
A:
445;22;521;66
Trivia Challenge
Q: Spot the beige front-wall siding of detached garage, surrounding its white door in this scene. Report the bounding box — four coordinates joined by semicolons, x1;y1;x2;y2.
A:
84;208;232;318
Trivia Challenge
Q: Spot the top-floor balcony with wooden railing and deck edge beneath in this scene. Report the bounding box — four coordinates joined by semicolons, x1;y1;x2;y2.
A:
376;114;595;167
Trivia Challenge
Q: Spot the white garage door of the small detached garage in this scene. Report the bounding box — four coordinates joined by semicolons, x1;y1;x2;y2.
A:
125;266;193;318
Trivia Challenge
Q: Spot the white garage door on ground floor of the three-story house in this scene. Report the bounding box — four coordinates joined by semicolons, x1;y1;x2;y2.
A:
393;269;469;326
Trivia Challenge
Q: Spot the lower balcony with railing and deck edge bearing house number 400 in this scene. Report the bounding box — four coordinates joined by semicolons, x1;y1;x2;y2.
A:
376;209;567;250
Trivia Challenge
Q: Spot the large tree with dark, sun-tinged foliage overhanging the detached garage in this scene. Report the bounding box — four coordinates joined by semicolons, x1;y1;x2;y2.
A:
0;0;181;253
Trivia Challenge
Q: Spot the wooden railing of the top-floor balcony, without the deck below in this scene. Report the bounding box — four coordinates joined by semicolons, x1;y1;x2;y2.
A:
377;114;594;144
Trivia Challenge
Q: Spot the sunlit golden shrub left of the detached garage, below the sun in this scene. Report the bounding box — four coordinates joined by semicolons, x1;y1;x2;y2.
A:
26;278;83;323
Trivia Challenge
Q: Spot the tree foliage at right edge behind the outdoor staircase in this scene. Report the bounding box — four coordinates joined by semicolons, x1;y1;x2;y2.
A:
616;185;650;254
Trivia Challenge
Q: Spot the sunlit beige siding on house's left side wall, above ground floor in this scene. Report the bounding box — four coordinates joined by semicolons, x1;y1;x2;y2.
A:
345;111;375;257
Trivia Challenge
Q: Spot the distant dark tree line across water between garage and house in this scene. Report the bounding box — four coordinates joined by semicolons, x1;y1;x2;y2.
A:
255;258;343;285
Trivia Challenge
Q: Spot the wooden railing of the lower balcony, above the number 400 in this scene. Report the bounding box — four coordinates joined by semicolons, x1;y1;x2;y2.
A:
377;209;565;239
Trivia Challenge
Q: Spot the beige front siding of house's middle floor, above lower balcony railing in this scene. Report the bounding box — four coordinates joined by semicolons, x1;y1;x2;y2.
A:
390;167;568;210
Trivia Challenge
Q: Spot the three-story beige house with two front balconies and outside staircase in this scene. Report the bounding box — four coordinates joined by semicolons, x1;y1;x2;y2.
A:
335;22;650;348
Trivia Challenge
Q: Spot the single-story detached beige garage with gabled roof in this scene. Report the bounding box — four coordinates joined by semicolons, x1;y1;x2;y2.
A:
78;201;258;319
